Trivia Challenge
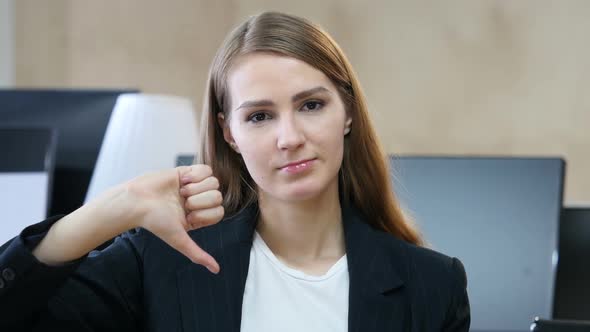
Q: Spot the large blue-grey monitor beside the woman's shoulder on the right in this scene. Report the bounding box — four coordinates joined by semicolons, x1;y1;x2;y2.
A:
390;156;565;331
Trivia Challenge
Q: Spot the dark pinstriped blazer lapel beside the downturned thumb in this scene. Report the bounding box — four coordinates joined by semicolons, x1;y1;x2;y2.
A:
177;207;258;332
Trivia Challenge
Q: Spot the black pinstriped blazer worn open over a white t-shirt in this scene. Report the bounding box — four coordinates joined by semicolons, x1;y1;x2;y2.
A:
0;206;470;332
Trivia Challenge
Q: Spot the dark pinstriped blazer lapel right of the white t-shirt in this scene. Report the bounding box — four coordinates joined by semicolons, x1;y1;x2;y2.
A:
342;207;411;332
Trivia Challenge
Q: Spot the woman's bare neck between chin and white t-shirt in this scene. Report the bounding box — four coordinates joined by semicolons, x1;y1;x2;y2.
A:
257;183;345;265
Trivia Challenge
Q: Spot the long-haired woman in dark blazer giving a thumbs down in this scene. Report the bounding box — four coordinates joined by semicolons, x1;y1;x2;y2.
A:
0;13;470;331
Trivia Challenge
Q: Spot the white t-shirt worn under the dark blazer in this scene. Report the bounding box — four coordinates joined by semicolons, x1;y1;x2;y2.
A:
241;232;349;332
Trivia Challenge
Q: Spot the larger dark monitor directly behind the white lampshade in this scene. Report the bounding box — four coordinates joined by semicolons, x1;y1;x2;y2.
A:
0;89;137;215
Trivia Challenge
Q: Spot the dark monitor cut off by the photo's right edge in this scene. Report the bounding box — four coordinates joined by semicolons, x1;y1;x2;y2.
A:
553;206;590;321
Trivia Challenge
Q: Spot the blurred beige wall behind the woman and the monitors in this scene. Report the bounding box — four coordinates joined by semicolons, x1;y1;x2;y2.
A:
15;0;590;204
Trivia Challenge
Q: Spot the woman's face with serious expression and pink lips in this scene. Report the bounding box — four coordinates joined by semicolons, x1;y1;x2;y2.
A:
220;53;351;201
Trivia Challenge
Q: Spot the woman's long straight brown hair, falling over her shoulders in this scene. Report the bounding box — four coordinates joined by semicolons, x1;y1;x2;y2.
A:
198;12;423;245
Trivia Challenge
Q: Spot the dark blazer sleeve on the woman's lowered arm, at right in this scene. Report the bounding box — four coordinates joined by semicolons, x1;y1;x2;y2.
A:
443;258;471;332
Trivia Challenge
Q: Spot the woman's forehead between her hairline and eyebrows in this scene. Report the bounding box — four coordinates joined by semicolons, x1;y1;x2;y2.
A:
227;53;336;105
